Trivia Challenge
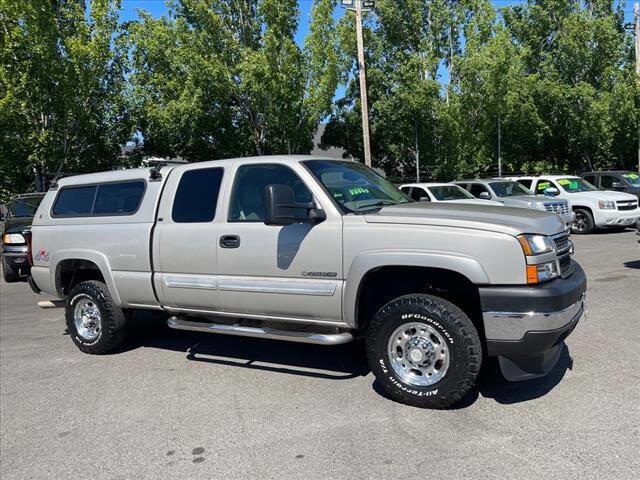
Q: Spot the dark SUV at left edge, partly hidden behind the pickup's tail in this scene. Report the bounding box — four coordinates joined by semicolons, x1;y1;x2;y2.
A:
2;193;44;283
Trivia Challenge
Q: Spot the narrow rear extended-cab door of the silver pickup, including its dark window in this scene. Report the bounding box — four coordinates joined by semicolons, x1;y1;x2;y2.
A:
153;166;225;310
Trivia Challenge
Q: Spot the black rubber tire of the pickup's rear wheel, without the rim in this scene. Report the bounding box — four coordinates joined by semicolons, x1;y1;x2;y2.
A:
65;280;127;355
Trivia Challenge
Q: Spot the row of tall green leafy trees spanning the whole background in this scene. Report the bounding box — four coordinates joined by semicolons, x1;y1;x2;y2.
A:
0;0;640;197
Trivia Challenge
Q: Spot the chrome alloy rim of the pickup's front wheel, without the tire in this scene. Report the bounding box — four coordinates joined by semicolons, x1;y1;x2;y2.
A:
387;322;450;387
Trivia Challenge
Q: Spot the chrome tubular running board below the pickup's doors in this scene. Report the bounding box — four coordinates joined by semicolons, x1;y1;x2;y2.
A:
167;317;353;345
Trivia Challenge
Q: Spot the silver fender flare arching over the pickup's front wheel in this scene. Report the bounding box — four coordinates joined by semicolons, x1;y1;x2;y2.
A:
342;250;491;327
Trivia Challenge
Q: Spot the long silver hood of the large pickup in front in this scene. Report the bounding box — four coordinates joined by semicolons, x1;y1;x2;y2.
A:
364;202;566;236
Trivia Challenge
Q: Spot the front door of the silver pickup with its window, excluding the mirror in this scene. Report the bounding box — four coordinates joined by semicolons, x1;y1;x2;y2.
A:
218;163;343;322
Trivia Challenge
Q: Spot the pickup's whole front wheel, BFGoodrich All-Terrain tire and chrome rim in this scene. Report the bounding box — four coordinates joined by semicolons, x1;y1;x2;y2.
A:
367;294;482;409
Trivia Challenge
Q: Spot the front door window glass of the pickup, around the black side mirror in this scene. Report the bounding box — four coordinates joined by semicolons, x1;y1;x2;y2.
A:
229;164;313;222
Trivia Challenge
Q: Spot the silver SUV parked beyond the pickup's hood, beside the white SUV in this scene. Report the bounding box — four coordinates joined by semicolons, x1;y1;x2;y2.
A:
454;178;575;226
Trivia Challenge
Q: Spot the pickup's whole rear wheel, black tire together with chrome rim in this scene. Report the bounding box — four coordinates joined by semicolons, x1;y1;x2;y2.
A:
65;280;127;355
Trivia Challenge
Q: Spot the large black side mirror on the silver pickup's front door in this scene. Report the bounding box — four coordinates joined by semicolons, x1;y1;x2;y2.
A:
264;184;327;226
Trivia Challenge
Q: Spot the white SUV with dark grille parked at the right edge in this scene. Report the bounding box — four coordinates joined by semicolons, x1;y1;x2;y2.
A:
511;175;640;234
